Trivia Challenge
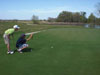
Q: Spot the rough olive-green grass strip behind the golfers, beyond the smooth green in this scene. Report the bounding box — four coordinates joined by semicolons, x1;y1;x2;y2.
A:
0;22;82;35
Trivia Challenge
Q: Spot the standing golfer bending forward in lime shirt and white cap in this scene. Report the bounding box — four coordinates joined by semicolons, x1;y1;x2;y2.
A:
3;25;20;54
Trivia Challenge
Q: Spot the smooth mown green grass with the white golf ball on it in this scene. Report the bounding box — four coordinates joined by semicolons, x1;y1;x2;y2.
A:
0;28;100;75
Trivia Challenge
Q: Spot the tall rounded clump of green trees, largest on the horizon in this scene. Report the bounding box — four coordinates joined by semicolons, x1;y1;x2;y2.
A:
57;11;87;23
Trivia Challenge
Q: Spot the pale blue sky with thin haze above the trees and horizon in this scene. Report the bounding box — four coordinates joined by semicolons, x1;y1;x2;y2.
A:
0;0;100;20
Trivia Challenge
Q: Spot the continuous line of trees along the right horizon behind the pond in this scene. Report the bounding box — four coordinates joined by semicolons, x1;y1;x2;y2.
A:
48;11;100;24
